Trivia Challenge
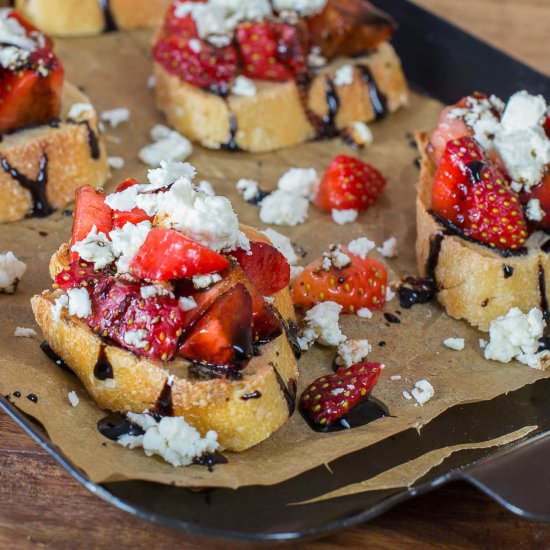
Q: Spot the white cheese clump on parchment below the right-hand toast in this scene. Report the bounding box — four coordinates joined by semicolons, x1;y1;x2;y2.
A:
484;307;550;369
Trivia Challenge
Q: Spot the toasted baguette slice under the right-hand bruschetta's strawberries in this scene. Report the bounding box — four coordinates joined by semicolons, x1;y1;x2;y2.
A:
416;132;550;331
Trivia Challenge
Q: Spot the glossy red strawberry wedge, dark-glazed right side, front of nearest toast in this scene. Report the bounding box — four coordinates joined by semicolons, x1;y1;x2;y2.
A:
179;284;252;367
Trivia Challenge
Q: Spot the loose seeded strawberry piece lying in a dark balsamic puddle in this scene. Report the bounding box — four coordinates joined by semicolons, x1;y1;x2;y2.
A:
300;363;382;427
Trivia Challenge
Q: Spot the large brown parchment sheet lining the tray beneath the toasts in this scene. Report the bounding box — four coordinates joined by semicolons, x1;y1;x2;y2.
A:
0;32;550;488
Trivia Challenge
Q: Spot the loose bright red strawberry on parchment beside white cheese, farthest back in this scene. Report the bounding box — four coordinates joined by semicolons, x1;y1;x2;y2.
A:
314;155;386;216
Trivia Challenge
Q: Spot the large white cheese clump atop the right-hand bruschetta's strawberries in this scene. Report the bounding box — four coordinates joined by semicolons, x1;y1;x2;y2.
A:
494;91;550;190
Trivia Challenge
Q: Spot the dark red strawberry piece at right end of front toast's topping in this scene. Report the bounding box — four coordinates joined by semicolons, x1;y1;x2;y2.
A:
231;242;290;296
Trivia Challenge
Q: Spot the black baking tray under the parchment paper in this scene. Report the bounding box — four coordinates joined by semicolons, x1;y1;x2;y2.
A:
0;0;550;543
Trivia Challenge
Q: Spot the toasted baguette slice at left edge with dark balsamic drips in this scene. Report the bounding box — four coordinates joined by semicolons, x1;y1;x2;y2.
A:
0;82;109;223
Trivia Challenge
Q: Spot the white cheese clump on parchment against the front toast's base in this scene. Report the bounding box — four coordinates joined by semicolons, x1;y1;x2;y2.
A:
117;413;219;467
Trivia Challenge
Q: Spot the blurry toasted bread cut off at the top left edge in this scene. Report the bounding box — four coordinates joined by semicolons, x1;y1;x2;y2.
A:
15;0;171;36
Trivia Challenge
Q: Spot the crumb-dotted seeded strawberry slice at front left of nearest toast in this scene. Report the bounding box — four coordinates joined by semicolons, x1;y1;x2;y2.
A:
89;278;182;361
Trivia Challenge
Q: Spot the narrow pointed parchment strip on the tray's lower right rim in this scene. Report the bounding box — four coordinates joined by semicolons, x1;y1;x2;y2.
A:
296;426;537;504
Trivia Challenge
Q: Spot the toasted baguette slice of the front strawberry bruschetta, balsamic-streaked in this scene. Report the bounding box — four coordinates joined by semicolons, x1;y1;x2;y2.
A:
31;229;298;451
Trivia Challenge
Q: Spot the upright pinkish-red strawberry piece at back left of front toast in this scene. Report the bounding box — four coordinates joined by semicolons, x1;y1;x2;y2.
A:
71;185;113;250
